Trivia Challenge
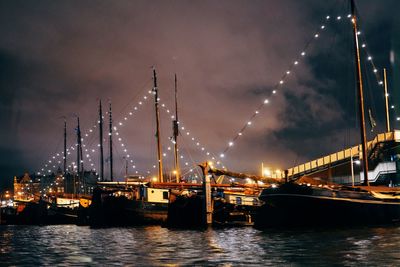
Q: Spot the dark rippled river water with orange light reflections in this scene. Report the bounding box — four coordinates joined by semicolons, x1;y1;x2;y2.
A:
0;225;400;266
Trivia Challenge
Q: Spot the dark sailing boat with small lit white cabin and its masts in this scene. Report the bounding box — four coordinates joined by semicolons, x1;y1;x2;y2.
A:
89;69;173;226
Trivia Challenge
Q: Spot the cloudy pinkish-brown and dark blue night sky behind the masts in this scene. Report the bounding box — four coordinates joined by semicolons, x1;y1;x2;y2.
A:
0;0;400;191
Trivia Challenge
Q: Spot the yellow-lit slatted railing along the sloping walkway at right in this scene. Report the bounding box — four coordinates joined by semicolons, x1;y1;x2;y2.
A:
288;130;400;177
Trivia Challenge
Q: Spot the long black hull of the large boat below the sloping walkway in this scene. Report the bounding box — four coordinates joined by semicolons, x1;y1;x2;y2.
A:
255;184;400;228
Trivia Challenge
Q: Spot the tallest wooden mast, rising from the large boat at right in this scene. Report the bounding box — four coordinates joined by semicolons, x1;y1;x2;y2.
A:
350;0;369;186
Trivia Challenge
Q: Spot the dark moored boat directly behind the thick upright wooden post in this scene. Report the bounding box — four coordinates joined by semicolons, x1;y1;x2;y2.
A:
166;183;261;228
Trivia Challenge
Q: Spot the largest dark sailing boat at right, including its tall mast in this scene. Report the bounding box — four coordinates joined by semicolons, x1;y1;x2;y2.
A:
255;0;400;228
